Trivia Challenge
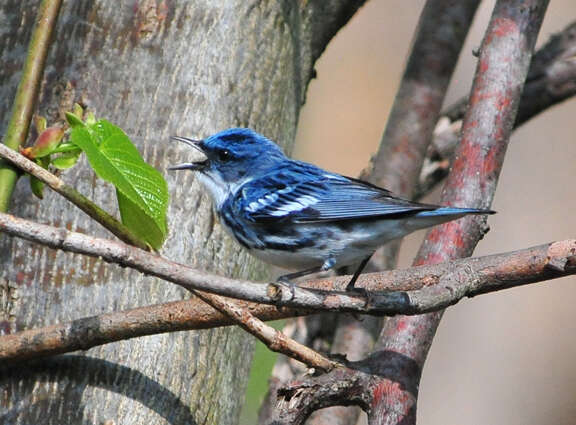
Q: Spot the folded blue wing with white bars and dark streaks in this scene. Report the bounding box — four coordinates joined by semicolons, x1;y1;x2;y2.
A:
237;161;437;223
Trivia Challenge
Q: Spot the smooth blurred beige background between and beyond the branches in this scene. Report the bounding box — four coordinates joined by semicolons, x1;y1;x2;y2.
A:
242;0;576;425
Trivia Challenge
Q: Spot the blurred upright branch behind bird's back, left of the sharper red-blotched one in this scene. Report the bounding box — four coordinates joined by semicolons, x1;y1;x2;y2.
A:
292;4;480;425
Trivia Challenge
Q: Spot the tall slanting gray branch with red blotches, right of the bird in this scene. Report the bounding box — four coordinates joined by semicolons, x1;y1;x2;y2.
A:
369;0;548;425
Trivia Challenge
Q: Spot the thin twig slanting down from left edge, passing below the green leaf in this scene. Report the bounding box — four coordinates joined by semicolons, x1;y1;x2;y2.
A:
0;144;150;250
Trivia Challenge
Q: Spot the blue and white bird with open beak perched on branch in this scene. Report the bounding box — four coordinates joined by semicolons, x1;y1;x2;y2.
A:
170;128;493;290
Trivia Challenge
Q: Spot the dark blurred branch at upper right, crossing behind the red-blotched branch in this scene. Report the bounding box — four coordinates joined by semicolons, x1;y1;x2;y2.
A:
414;18;576;199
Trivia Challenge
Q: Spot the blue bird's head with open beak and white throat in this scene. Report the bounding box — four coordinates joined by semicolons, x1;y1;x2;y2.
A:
169;128;286;205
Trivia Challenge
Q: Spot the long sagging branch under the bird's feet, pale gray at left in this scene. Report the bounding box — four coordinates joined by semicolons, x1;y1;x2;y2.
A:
0;213;574;315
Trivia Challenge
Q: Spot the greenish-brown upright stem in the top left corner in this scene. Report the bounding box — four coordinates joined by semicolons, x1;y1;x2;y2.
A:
0;0;62;212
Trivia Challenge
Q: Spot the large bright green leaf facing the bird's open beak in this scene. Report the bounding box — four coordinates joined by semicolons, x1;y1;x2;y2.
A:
70;120;168;249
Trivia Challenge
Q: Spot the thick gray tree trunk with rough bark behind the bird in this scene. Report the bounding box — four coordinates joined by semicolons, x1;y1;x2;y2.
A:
0;0;362;425
